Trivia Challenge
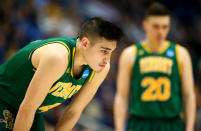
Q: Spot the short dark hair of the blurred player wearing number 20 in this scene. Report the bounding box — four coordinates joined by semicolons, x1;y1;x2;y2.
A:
145;2;170;18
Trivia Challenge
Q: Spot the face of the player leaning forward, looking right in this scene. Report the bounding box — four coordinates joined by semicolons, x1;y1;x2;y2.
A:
84;38;117;72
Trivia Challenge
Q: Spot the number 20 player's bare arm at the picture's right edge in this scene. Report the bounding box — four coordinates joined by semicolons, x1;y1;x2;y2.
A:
178;46;196;131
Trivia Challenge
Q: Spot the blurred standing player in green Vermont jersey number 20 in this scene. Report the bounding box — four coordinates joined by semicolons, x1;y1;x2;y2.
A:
114;3;195;131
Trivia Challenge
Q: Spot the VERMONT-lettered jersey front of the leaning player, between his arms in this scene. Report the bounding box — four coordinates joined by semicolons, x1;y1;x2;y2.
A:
37;41;94;112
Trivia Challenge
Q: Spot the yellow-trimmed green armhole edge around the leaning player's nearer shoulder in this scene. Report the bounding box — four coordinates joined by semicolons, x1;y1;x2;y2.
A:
28;41;71;72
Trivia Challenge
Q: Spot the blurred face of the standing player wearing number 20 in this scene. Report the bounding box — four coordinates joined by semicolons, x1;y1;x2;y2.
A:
143;16;170;43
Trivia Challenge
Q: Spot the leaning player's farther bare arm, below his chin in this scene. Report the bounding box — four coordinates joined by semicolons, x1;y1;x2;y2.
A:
56;63;110;131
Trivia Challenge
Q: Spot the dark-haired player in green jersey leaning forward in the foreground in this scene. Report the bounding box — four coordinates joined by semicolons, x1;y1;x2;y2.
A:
0;18;122;131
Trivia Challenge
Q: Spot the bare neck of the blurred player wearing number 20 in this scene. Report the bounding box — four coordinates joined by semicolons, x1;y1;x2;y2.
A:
144;39;165;53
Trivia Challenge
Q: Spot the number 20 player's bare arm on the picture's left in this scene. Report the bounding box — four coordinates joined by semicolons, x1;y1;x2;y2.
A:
114;45;136;131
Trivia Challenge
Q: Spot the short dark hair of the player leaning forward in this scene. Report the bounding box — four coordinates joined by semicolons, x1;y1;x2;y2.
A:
79;17;123;40
